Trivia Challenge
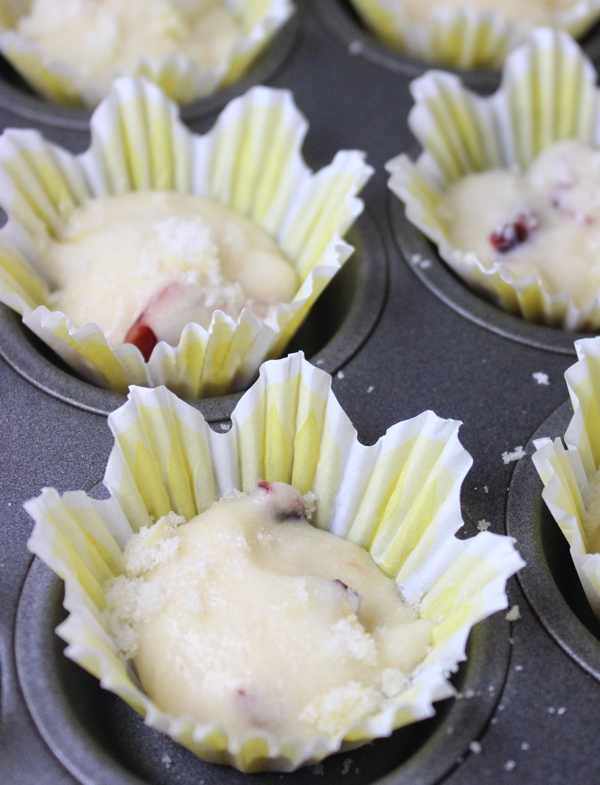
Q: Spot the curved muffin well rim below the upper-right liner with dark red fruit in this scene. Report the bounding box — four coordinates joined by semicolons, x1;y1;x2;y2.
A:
388;194;591;356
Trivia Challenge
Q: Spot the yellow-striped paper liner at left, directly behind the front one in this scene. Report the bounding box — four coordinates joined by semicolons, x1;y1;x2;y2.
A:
0;78;373;399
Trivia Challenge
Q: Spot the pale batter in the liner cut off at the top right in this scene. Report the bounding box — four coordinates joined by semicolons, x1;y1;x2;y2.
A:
395;0;578;27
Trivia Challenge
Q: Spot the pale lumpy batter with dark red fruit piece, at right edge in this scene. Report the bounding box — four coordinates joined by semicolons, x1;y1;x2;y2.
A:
439;140;600;309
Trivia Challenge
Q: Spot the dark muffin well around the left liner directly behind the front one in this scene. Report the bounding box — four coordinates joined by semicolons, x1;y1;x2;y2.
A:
0;213;388;422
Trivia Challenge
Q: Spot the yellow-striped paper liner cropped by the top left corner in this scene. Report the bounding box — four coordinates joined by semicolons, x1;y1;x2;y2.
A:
0;0;295;109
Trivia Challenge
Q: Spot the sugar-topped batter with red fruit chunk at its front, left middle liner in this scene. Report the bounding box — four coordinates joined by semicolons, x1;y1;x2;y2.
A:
36;192;298;348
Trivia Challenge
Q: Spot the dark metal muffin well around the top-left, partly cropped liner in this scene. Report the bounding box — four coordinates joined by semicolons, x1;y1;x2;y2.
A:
0;8;304;133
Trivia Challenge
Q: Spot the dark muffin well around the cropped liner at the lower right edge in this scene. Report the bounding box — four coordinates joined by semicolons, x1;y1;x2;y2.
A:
506;401;600;681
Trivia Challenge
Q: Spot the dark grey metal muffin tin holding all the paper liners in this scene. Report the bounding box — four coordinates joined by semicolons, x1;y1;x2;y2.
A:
0;0;600;785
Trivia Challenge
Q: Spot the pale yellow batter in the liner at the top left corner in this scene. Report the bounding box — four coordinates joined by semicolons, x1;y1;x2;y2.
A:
17;0;243;84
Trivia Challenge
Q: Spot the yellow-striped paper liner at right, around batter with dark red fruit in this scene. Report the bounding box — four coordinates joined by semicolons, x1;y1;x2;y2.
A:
386;29;600;330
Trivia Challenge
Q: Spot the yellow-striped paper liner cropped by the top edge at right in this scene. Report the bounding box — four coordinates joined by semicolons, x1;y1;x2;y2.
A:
351;0;600;68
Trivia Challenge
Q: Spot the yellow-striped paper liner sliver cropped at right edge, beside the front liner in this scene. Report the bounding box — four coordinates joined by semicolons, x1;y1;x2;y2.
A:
533;338;600;618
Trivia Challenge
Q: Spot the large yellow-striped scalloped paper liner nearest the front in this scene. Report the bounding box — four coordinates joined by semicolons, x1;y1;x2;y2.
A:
26;353;523;771
